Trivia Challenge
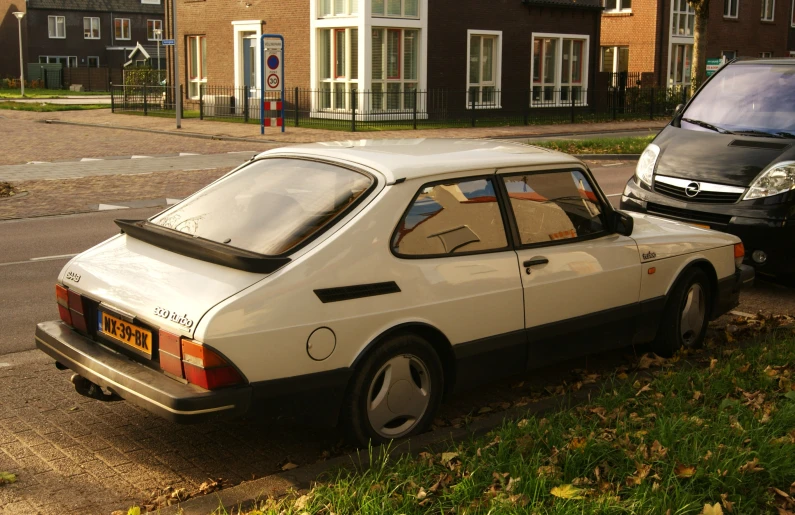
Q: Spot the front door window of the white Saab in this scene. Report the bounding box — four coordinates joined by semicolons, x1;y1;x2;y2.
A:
503;170;605;245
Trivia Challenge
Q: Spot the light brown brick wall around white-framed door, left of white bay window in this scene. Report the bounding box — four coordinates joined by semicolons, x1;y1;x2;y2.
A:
173;0;309;88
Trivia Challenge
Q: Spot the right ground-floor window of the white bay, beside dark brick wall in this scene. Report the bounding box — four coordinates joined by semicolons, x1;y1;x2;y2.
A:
370;28;420;109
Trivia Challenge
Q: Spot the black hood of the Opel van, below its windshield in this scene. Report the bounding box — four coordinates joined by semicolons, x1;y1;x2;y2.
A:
654;125;795;187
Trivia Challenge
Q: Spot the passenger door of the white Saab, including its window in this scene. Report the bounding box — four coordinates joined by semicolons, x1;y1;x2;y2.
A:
500;168;641;367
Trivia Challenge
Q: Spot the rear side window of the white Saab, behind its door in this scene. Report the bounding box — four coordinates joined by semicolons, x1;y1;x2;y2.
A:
392;178;508;256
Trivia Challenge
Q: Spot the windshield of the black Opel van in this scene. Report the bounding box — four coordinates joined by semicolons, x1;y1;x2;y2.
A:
682;62;795;138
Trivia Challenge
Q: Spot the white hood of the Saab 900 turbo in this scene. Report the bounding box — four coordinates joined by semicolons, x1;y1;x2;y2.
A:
628;213;740;261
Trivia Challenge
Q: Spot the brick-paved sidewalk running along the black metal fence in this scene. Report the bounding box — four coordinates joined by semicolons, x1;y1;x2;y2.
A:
15;110;668;144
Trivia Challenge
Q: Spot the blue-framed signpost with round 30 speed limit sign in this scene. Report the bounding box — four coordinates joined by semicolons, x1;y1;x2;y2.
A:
259;34;284;134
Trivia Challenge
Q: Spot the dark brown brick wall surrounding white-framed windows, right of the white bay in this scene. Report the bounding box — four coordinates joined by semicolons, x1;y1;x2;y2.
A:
428;0;600;103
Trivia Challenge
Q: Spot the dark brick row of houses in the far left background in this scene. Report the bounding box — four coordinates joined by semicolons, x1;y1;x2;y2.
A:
0;0;165;76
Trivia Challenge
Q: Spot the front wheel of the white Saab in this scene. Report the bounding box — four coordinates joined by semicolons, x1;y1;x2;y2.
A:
652;268;711;356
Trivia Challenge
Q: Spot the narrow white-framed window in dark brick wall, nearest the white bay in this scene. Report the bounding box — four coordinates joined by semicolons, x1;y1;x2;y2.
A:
467;31;502;108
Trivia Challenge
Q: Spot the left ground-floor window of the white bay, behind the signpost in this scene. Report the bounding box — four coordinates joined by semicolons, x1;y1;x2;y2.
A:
318;28;359;109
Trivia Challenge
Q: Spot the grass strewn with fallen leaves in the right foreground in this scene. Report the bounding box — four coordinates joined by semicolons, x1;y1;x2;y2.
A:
210;319;795;515
